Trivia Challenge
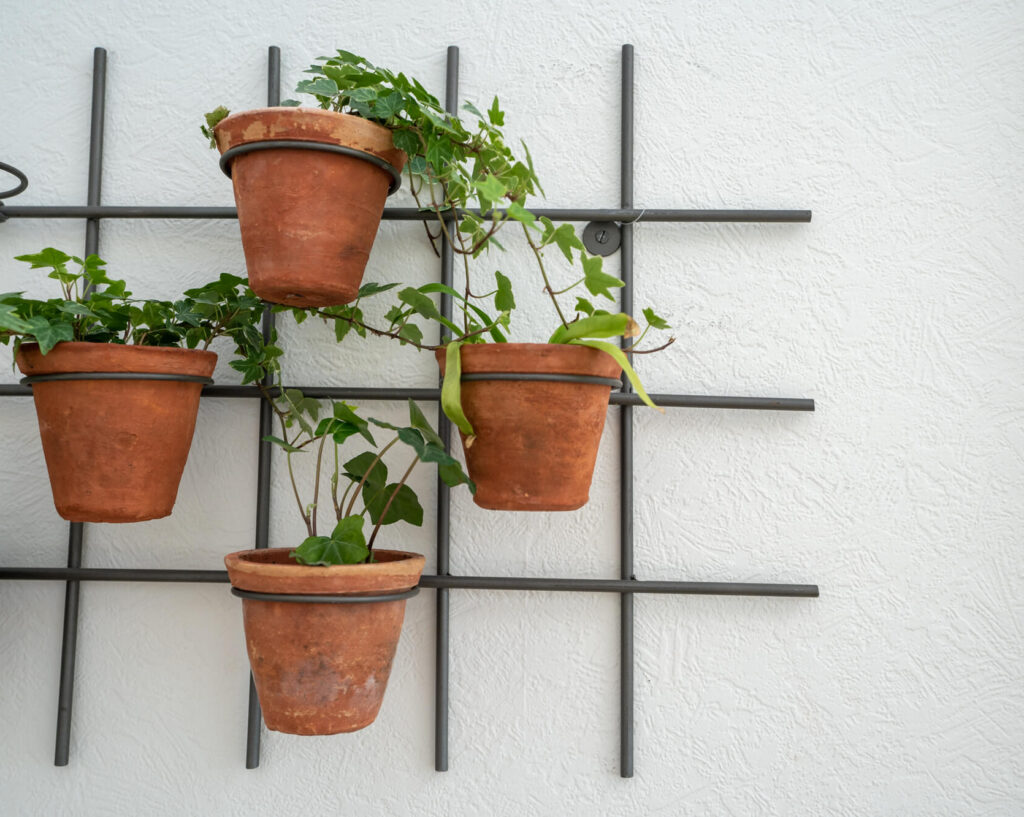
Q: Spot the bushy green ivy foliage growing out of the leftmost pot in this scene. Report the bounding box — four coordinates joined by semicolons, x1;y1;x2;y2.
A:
0;247;264;354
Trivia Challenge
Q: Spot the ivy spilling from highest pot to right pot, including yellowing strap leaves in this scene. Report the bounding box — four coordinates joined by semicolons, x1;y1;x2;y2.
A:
204;50;674;435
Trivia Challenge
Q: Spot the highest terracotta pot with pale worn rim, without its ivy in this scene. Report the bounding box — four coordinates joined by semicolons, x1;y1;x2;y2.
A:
214;108;407;306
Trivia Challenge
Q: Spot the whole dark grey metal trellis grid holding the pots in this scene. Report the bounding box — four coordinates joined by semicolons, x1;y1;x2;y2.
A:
0;45;818;777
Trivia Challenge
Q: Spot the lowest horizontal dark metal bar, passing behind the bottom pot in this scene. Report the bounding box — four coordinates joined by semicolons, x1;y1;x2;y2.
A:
0;567;818;598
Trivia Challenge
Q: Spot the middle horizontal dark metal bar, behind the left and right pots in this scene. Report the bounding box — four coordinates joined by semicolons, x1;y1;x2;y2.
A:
0;385;814;412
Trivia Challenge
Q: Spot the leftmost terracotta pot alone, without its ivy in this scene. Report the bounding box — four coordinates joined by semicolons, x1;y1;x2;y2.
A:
16;343;217;522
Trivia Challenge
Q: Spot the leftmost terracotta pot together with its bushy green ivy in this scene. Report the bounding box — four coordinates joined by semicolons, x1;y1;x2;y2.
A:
0;248;263;522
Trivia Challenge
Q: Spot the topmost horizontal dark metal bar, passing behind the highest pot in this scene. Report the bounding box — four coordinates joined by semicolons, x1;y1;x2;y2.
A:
0;205;811;223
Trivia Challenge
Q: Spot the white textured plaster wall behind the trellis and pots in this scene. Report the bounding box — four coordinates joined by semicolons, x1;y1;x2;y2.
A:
0;0;1024;815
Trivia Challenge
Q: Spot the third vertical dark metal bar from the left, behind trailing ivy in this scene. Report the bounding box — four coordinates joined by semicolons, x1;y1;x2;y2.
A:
434;45;459;772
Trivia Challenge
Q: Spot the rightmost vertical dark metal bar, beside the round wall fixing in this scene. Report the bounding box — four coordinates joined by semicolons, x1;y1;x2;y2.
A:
618;45;636;777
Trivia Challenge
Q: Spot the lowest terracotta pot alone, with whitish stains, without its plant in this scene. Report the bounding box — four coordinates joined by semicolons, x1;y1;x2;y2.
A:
224;548;424;735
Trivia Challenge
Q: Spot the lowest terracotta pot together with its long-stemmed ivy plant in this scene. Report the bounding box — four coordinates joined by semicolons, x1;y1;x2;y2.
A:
224;339;474;735
